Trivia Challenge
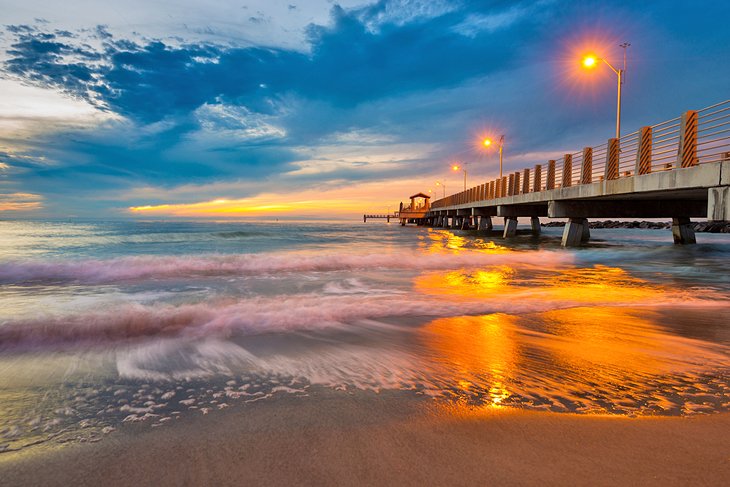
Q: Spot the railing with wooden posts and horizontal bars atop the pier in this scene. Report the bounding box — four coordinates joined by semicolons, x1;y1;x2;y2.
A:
431;100;730;209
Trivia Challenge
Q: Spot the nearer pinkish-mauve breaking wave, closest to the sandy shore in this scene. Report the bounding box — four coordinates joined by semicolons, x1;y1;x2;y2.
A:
0;288;721;351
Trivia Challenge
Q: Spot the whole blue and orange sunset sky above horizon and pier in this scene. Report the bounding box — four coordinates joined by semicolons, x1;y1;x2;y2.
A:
0;0;730;219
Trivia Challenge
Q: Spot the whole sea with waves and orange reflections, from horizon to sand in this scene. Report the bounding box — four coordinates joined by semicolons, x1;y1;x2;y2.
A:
0;221;730;452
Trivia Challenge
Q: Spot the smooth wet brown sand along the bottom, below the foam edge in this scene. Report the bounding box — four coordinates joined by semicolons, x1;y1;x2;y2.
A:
0;391;730;486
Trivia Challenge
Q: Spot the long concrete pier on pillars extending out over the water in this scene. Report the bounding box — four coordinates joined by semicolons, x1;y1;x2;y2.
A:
401;100;730;247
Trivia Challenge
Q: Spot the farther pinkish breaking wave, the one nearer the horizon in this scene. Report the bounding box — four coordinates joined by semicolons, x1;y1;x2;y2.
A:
0;251;573;284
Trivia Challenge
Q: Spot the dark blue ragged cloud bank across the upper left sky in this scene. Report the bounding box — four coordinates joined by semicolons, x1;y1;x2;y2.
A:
5;2;532;123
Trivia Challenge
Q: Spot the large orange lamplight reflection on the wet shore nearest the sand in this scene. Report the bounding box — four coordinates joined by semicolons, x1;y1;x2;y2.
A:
421;306;730;414
